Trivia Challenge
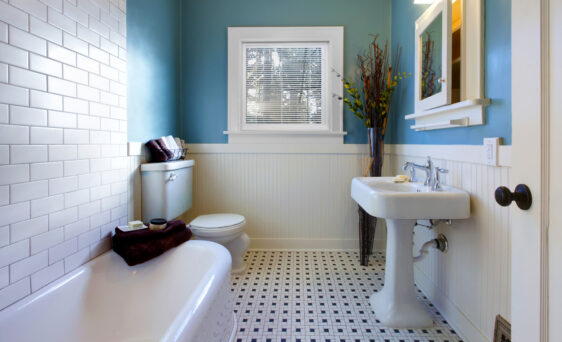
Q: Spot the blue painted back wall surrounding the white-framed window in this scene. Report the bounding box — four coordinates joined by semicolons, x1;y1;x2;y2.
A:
180;0;390;143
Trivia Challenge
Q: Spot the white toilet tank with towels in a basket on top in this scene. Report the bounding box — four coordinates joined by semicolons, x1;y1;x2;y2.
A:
141;160;194;222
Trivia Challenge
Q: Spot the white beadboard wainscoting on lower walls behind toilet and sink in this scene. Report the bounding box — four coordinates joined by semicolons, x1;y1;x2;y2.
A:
130;144;511;342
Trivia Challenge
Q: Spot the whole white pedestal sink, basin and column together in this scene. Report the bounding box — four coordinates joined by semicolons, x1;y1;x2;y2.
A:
351;177;470;329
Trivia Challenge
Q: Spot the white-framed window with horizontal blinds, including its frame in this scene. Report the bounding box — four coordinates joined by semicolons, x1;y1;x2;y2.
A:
225;27;345;143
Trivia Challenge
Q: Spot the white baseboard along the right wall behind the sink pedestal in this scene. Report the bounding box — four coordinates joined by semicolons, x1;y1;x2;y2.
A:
414;268;490;342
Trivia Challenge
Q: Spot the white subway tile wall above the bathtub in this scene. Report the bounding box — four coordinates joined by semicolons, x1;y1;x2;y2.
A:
0;0;128;309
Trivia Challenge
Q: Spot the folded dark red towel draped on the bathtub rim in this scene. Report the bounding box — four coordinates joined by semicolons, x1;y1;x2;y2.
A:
113;220;192;266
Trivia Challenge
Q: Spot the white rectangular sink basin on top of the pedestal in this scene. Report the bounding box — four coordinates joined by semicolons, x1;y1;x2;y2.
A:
351;177;470;220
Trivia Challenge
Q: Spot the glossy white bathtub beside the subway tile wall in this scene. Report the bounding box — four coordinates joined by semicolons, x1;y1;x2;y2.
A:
0;241;235;342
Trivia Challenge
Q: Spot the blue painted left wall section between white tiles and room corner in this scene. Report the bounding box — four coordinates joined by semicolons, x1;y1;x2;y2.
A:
127;0;180;141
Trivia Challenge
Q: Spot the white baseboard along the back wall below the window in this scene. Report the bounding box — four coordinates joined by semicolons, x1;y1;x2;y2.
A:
250;237;385;250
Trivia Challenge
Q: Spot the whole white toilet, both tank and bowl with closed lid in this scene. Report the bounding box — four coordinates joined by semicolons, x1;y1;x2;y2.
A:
140;160;250;273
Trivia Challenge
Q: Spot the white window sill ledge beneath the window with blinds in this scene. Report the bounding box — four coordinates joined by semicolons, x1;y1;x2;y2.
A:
223;131;347;144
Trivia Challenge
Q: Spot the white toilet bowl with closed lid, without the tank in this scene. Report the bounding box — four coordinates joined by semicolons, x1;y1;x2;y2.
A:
189;214;250;273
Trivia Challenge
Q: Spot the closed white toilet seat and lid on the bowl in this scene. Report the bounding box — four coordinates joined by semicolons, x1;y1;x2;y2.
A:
189;214;246;236
